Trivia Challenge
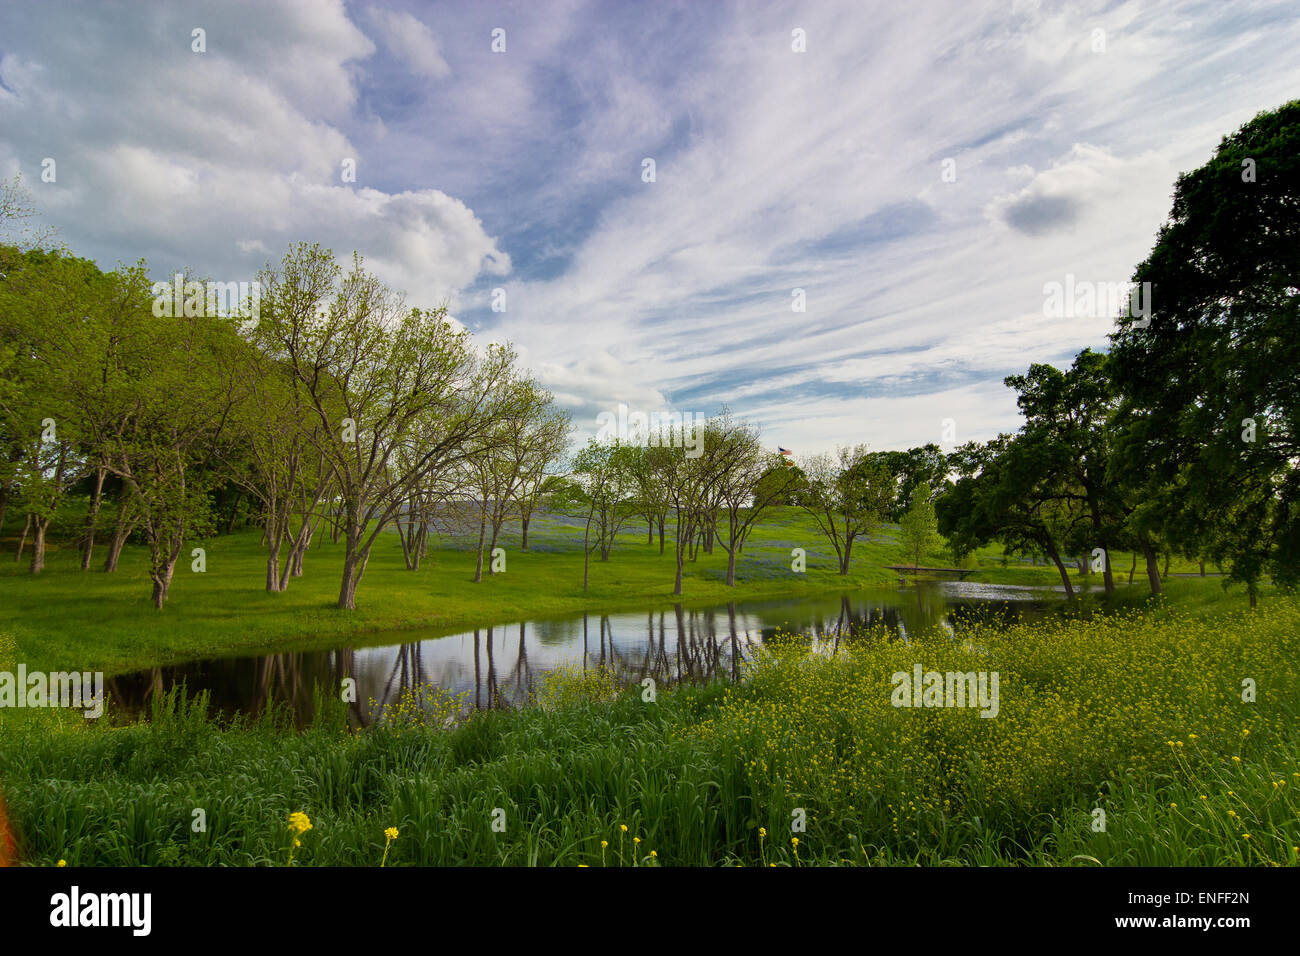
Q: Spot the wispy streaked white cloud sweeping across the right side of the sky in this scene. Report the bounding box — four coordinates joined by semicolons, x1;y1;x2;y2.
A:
486;3;1300;455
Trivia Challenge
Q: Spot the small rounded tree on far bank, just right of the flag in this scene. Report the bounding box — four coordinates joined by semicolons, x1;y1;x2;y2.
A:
801;445;896;575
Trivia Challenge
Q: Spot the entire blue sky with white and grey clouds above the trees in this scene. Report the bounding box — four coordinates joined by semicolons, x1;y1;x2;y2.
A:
0;0;1300;455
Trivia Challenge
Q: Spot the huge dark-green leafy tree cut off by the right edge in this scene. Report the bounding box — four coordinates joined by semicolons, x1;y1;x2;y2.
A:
1112;100;1300;596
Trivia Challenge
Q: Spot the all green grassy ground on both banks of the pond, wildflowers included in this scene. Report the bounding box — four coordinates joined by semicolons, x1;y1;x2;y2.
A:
0;510;1284;866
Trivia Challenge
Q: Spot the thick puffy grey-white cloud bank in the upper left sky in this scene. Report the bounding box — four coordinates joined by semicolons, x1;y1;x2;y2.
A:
0;3;510;316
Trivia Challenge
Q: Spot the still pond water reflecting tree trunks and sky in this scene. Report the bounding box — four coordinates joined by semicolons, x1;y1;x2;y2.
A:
107;581;1062;726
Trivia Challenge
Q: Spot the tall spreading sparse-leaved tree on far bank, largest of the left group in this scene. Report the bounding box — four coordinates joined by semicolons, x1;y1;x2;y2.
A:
254;243;514;610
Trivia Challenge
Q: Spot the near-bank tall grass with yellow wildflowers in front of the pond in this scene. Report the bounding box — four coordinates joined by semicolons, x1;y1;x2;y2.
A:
0;597;1300;866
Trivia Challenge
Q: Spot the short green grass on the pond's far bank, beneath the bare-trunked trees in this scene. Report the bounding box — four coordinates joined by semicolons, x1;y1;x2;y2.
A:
0;509;1193;674
